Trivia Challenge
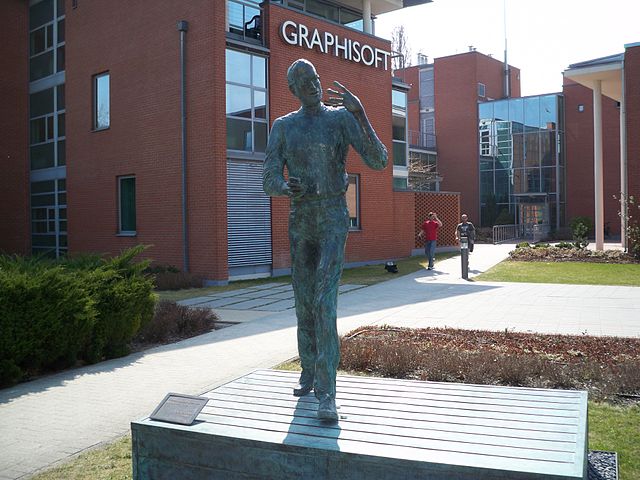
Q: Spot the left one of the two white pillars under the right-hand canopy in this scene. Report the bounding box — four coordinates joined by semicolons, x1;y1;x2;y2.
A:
593;80;604;250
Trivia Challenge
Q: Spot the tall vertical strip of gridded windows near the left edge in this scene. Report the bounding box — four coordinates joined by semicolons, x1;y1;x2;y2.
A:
29;0;67;257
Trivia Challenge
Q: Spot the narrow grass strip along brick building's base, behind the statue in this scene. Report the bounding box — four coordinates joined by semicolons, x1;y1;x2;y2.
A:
156;252;457;301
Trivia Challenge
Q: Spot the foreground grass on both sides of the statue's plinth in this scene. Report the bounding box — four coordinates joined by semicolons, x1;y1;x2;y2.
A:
33;402;640;480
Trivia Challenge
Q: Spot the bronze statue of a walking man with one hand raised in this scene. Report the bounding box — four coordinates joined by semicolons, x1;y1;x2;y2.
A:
263;59;387;422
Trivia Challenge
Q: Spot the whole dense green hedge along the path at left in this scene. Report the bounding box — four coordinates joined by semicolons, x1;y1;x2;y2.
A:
0;246;155;386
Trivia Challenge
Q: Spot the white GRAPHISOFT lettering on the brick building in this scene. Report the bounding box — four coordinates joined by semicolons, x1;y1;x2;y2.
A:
280;20;391;70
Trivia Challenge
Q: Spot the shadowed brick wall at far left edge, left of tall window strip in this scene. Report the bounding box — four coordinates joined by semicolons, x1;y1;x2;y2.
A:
0;0;30;254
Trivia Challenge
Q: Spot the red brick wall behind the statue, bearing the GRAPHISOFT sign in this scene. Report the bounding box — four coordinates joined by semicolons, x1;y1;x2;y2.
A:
268;4;413;269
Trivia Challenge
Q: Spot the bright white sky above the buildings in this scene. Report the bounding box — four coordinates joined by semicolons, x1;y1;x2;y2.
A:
375;0;640;96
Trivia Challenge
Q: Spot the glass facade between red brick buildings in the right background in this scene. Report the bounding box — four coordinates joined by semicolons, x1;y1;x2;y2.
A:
478;94;566;229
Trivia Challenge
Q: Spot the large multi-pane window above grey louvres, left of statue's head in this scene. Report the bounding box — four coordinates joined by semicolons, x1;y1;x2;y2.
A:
226;50;267;153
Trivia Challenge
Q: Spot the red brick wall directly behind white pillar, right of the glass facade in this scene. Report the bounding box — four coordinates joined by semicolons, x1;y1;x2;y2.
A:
563;79;620;235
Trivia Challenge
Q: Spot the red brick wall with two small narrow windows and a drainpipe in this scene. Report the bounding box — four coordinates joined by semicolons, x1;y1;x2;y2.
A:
66;0;227;279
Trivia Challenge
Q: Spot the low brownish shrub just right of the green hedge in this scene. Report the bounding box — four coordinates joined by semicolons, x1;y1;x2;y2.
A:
134;300;219;343
